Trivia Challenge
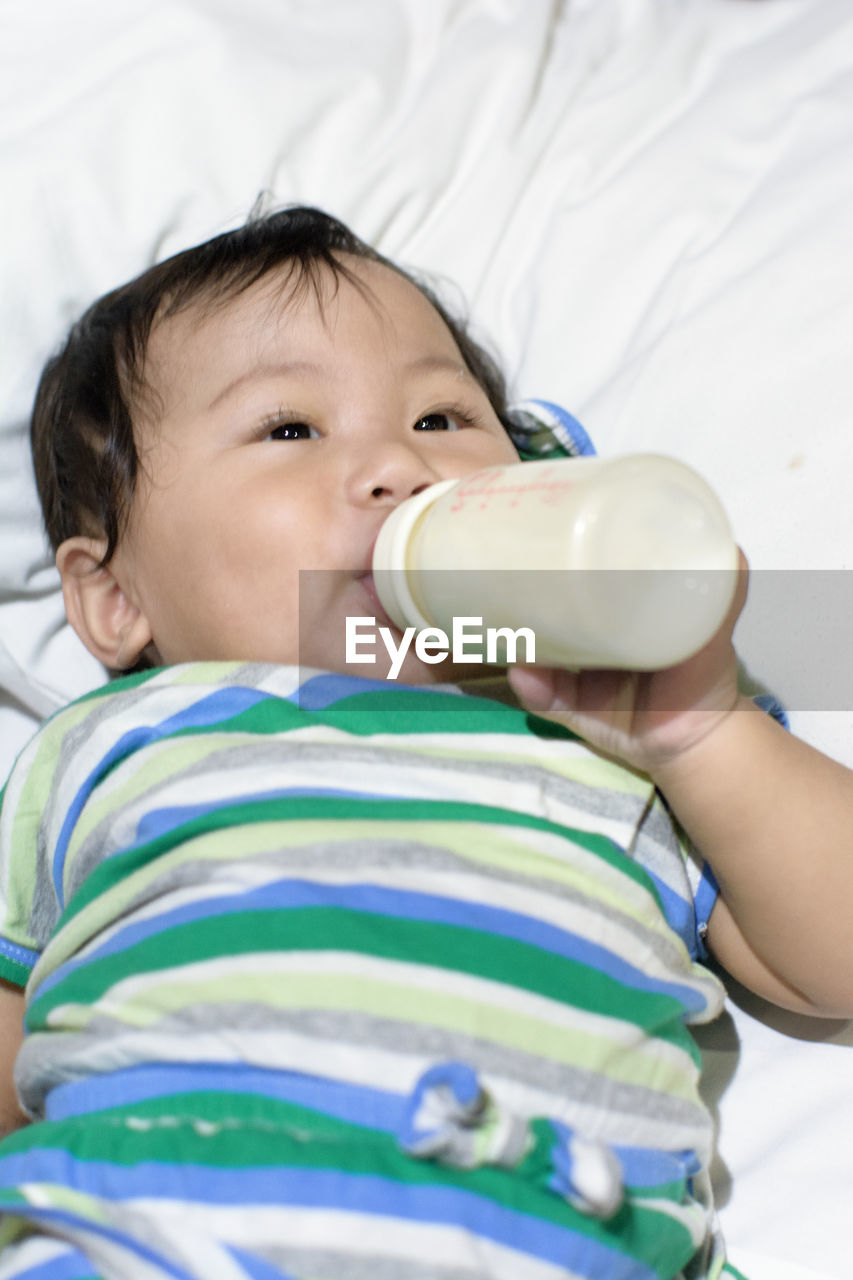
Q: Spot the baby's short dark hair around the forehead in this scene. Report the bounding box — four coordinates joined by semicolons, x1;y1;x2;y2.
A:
31;206;510;564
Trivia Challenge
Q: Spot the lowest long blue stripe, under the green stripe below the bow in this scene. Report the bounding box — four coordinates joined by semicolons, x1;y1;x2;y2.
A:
0;1167;655;1280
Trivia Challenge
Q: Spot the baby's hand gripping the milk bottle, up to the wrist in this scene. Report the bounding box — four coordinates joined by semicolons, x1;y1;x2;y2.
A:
508;554;748;777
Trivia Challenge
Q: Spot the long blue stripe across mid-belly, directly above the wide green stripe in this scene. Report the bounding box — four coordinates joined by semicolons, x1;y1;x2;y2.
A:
38;878;707;1014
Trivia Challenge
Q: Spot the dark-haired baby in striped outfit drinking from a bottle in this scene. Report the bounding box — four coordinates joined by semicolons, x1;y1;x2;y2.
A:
0;209;853;1280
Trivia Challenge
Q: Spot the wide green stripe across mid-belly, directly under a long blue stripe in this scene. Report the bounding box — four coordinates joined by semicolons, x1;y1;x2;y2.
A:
27;906;683;1044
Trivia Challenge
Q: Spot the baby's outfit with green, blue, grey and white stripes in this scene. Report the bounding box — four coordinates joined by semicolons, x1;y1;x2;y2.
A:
0;663;726;1280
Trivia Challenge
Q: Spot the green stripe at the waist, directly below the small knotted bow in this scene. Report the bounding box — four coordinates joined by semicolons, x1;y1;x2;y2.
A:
4;1093;694;1275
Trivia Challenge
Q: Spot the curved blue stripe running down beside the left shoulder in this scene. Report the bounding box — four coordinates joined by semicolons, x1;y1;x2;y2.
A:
53;686;269;906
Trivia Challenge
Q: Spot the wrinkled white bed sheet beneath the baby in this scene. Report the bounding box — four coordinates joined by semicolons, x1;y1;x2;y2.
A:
0;0;853;1280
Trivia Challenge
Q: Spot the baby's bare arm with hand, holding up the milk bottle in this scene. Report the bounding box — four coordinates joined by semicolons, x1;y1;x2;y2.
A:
510;566;853;1018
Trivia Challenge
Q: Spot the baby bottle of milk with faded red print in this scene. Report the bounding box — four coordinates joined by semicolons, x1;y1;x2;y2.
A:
373;453;738;671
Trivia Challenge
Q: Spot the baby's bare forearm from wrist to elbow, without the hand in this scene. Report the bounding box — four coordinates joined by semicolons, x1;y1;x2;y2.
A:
645;699;853;1018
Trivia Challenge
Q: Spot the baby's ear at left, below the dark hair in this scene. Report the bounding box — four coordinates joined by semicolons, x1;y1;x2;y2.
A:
56;536;151;671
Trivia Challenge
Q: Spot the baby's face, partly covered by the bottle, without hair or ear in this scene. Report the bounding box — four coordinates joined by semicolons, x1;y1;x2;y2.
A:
110;259;517;682
